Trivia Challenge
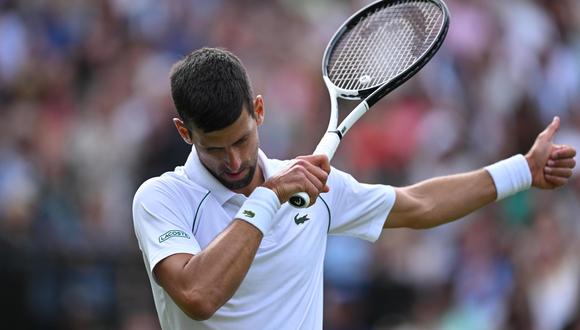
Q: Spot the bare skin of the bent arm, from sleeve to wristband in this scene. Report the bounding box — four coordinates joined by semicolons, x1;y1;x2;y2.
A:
153;220;262;321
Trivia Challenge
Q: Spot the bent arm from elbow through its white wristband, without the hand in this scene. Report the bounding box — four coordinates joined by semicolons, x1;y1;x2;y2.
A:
157;187;280;320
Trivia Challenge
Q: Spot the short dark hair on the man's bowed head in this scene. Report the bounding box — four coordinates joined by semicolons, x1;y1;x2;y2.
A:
170;48;254;133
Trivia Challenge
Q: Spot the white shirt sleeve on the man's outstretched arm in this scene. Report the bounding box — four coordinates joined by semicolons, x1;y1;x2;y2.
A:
329;168;396;242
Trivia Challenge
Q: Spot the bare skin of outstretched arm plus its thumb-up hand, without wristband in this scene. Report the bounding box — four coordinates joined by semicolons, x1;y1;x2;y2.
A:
384;118;576;228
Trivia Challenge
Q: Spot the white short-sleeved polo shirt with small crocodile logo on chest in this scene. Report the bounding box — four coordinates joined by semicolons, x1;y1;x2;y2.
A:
133;149;395;330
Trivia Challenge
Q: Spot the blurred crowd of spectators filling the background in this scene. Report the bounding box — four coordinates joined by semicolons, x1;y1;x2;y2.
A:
0;0;580;330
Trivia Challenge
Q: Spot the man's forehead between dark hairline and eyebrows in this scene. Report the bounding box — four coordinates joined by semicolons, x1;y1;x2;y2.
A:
192;109;256;147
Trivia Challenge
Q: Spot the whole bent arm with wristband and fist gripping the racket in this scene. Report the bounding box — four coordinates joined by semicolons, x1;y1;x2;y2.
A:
153;155;330;320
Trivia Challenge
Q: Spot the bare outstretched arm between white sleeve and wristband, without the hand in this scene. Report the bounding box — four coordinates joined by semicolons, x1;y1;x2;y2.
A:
384;169;497;229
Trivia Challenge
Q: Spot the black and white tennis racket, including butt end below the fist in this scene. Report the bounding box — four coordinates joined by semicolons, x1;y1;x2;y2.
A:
289;0;449;208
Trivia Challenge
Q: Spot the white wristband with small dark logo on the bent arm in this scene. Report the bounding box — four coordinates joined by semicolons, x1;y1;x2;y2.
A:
236;187;280;235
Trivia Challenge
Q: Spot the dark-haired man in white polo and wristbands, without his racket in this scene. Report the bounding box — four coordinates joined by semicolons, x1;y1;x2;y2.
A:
133;48;576;329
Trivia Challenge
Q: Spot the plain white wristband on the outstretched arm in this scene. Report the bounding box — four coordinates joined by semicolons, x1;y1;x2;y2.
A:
485;155;532;200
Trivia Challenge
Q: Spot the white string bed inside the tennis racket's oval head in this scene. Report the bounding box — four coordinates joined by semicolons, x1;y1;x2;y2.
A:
328;1;443;90
